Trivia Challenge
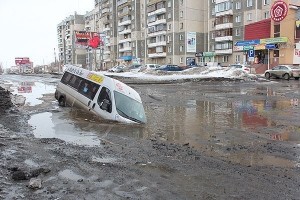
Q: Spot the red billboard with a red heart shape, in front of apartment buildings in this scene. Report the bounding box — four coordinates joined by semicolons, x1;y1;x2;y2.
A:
74;31;101;49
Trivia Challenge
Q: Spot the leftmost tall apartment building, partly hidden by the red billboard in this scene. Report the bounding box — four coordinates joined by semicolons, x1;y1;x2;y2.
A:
57;12;86;67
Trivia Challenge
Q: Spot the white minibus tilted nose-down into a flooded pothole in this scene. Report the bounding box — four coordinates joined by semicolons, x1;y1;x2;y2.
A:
55;65;146;124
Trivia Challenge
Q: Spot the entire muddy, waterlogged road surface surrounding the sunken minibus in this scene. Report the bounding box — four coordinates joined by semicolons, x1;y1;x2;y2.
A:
0;75;300;200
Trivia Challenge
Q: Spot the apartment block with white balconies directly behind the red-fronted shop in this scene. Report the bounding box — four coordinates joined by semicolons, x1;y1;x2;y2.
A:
209;0;271;66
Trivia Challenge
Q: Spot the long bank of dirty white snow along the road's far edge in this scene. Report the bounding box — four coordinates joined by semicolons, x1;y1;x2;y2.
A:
98;67;257;80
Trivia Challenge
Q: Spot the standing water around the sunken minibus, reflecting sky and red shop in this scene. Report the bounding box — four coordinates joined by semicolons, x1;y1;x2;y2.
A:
2;74;300;167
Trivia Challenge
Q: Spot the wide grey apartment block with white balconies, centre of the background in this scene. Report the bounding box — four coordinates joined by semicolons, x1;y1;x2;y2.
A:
79;0;208;69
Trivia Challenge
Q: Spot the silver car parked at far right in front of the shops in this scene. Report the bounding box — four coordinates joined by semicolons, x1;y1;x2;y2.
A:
265;65;300;80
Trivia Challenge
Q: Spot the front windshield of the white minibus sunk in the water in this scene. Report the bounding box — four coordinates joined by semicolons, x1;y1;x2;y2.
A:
114;91;147;123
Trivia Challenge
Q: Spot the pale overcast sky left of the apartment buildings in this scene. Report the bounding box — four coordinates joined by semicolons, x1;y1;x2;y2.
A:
0;0;94;68
